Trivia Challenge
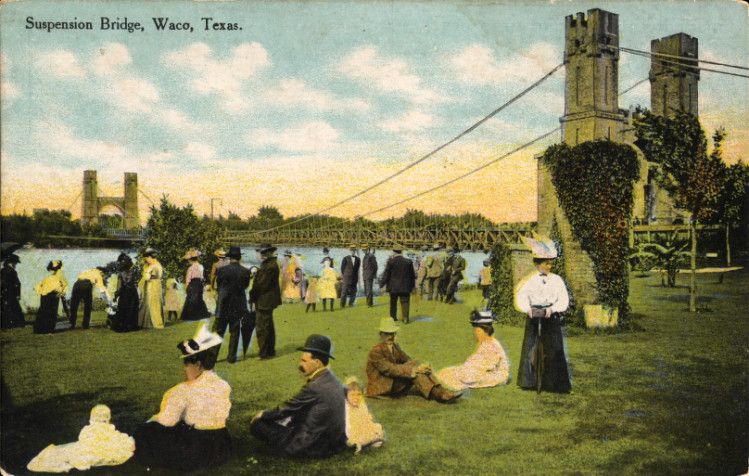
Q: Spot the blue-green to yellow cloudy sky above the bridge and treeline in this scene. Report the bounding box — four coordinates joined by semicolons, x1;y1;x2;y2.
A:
0;0;749;222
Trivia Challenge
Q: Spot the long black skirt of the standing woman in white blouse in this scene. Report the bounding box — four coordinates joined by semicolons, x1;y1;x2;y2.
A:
518;314;572;393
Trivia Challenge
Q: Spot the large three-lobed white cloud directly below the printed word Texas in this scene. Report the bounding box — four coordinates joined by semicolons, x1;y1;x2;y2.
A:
163;42;270;111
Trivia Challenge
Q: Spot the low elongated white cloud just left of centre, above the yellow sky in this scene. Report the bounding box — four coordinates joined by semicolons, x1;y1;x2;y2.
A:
247;121;339;152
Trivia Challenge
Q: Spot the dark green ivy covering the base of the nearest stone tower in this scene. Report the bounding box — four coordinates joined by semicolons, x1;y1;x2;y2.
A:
542;141;639;320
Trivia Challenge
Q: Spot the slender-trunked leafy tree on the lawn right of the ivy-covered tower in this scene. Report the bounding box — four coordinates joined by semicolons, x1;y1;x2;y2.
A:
633;109;726;312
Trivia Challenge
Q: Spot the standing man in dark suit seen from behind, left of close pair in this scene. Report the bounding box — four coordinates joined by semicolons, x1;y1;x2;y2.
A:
213;246;255;364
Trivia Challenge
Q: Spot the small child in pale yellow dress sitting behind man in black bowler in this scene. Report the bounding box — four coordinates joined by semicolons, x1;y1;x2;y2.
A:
346;376;385;454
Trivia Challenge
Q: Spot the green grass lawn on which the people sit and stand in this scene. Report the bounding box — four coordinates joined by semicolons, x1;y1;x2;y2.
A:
1;271;749;475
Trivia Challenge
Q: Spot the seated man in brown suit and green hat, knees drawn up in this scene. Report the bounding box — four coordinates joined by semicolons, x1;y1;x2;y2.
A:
367;317;461;403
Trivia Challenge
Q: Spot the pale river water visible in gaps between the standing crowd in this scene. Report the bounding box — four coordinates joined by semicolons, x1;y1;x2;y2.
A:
11;246;488;309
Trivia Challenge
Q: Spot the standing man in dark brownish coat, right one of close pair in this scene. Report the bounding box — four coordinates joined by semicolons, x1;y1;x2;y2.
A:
250;244;281;360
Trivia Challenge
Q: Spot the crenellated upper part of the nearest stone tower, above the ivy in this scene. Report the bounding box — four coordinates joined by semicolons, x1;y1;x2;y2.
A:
560;9;626;145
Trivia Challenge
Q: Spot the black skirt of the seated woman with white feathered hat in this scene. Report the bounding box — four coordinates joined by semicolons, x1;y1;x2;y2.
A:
134;421;232;470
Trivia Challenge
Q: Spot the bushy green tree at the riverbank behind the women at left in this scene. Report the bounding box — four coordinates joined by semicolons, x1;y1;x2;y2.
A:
141;197;221;278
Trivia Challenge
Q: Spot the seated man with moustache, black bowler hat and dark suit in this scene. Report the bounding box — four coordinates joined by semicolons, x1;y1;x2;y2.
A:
250;334;346;457
